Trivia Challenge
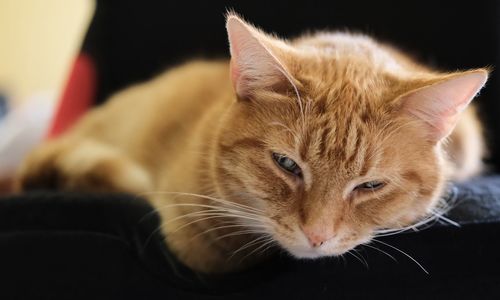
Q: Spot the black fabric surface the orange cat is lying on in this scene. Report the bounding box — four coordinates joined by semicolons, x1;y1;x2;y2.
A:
0;177;500;299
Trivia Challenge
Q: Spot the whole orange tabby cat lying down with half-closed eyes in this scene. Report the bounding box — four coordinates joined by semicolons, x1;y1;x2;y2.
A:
16;13;488;273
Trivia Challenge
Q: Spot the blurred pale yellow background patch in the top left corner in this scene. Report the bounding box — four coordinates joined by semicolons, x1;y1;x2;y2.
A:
0;0;95;105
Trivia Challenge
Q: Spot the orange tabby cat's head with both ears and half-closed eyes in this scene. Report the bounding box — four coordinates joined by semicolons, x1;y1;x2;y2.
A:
214;14;487;257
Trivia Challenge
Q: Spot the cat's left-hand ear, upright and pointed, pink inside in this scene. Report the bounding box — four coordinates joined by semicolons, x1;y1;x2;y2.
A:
226;14;291;99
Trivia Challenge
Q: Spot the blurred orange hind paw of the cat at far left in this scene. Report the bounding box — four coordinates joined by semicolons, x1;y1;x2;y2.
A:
15;140;151;194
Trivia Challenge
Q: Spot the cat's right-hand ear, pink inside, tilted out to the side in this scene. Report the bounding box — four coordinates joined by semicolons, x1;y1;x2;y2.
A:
401;69;488;142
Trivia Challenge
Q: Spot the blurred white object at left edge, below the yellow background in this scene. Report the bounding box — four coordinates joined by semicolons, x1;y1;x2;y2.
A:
0;92;57;179
